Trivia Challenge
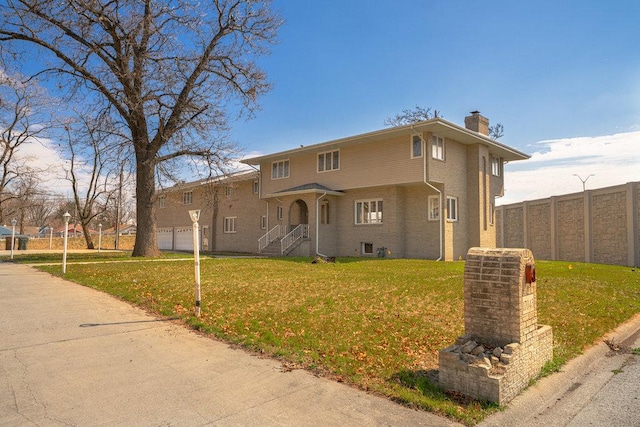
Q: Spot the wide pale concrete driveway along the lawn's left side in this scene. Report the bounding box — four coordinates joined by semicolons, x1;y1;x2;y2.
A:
0;262;459;426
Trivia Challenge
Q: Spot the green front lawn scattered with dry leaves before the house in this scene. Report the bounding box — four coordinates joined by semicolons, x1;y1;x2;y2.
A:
11;258;640;425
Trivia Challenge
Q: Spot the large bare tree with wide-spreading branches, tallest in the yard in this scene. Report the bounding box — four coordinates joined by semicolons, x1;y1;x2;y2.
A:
0;0;281;256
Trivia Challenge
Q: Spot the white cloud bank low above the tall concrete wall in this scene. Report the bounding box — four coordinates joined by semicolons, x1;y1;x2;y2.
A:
496;132;640;205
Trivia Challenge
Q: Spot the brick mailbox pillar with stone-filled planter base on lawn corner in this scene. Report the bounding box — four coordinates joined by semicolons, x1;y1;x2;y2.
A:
439;248;553;405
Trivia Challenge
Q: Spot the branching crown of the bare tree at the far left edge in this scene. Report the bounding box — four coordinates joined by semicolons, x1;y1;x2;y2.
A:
0;69;48;223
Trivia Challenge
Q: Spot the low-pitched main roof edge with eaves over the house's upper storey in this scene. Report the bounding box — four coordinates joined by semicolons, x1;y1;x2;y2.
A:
242;118;530;165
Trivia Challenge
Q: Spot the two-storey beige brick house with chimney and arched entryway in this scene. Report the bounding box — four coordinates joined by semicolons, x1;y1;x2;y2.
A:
158;112;528;260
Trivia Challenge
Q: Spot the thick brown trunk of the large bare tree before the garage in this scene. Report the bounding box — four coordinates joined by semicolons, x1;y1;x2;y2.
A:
132;155;160;257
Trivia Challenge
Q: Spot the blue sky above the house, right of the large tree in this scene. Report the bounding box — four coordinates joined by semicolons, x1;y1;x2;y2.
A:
233;0;640;201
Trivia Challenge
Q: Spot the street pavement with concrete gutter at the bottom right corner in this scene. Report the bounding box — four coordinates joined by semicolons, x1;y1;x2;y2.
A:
479;314;640;427
